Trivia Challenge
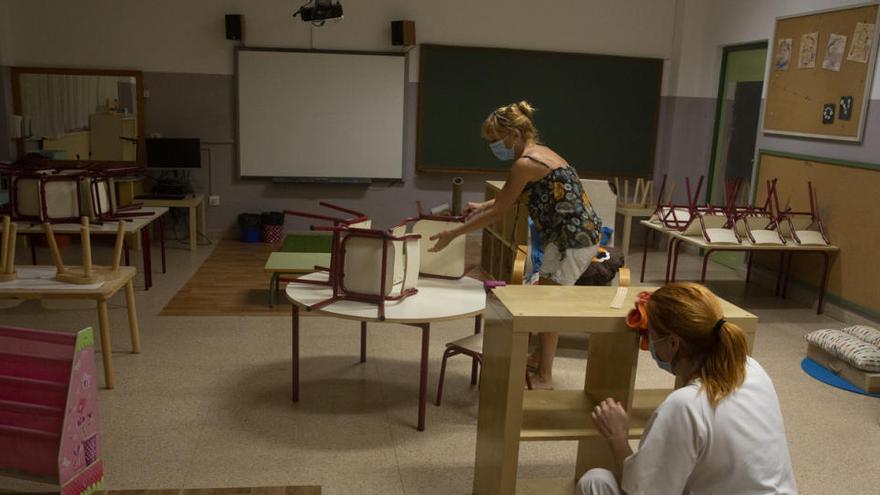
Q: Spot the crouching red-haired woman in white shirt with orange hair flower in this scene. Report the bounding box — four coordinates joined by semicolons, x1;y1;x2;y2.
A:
578;283;797;495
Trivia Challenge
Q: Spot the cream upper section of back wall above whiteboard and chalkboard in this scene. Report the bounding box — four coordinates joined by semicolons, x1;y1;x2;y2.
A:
7;0;675;79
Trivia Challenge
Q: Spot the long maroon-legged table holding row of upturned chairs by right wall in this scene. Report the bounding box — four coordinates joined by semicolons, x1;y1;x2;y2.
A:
639;220;840;314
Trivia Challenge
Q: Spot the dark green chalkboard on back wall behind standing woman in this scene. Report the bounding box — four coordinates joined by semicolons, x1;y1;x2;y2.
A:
416;45;663;177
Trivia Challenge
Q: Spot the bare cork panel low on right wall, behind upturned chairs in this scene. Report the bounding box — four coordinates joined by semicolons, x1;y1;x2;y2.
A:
755;150;880;315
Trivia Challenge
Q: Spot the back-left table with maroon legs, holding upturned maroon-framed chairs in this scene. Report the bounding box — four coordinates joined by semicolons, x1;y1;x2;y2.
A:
9;207;168;290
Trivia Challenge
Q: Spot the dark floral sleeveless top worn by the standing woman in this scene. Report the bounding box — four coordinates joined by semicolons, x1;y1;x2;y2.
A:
521;157;602;257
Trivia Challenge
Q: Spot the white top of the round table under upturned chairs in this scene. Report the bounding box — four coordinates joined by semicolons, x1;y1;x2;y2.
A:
285;272;486;323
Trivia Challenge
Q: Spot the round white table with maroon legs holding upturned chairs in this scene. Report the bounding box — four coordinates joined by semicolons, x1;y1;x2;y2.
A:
286;272;484;431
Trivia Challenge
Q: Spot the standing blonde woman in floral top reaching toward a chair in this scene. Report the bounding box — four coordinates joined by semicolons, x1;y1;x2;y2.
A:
431;101;602;389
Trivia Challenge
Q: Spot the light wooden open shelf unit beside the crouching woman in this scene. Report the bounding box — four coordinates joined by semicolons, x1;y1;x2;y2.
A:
473;285;758;495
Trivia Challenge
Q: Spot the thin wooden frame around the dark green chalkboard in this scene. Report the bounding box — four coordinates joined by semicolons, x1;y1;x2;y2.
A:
415;44;664;178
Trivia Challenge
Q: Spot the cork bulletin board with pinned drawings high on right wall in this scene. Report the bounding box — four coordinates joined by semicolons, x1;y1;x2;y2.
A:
763;3;878;141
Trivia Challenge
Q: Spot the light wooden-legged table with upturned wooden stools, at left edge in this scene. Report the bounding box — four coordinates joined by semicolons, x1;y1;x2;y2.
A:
0;266;141;388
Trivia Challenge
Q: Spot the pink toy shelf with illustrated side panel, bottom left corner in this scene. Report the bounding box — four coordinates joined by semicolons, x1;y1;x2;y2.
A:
0;325;104;495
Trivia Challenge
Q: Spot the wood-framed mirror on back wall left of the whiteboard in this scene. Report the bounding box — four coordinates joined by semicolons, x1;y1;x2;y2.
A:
12;67;144;167
